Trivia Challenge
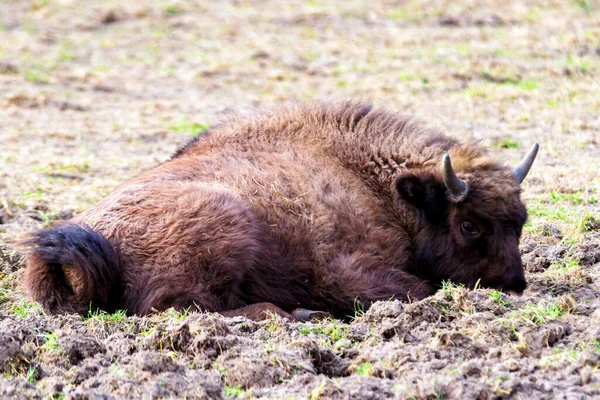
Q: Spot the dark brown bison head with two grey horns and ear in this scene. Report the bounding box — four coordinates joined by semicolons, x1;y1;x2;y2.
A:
395;144;538;293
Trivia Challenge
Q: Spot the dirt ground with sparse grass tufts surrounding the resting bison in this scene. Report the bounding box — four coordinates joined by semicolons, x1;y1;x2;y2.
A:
0;0;600;399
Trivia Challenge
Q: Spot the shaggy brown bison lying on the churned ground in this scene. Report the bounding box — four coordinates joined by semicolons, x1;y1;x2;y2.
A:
24;103;538;319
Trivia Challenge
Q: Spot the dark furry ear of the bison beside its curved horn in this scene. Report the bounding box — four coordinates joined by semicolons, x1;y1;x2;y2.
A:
396;173;444;215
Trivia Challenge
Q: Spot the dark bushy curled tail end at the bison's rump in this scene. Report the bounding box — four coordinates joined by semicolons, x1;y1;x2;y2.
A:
23;223;123;315
